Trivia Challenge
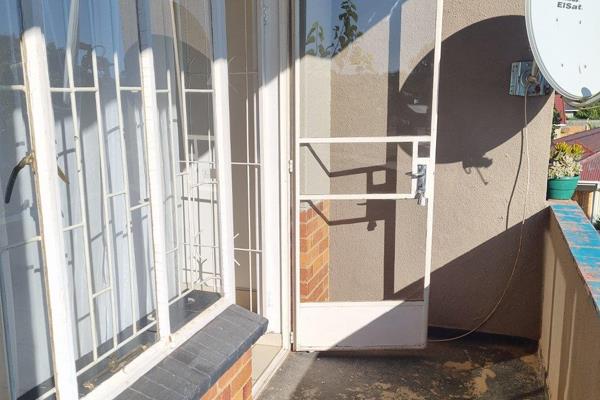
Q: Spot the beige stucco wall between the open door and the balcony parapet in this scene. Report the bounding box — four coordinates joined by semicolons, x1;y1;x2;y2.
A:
430;0;552;338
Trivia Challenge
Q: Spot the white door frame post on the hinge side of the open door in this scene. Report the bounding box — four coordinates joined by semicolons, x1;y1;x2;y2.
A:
252;0;292;398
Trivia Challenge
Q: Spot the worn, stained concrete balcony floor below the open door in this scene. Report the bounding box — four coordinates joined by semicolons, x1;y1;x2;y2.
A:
258;335;547;400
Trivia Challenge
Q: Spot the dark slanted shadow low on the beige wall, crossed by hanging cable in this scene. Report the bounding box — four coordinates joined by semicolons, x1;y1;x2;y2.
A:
414;210;548;339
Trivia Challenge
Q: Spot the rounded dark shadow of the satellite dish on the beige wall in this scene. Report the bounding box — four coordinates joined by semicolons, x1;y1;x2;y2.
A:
400;16;550;168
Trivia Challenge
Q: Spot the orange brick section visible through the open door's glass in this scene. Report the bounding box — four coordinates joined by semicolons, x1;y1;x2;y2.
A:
300;201;330;302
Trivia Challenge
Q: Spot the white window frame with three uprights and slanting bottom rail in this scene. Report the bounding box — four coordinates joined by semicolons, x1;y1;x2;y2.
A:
16;0;235;400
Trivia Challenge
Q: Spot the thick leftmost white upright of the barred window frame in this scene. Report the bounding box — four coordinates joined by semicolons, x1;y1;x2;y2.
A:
21;14;78;400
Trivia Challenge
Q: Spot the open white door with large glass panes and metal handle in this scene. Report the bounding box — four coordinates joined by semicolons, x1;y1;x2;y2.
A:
294;0;442;350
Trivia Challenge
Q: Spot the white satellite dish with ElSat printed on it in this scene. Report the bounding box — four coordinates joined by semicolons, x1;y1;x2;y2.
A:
526;0;600;106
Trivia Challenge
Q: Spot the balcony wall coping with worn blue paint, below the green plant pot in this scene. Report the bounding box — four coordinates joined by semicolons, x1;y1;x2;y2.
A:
550;201;600;316
